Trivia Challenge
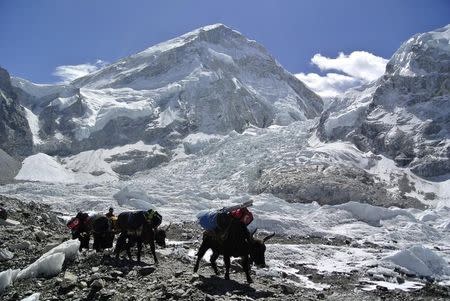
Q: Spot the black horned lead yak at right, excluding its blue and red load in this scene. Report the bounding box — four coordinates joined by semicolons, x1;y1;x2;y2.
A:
194;217;275;283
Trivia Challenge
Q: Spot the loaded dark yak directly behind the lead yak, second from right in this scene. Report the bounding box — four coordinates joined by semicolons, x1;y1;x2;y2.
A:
115;210;170;264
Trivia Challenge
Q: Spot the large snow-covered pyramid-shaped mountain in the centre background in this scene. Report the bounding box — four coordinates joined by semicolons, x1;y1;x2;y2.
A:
14;24;323;155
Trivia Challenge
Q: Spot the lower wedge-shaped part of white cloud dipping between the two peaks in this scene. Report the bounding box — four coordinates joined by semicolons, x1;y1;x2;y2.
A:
295;73;363;98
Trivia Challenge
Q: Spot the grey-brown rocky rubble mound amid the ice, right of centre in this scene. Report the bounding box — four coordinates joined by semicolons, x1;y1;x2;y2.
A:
253;164;424;208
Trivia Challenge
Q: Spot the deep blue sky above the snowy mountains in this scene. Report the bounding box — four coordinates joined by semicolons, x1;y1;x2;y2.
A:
0;0;450;95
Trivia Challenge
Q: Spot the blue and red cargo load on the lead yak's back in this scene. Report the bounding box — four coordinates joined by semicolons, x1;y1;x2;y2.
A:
197;200;253;231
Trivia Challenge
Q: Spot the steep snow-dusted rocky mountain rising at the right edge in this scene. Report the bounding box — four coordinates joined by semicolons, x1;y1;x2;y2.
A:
319;25;450;177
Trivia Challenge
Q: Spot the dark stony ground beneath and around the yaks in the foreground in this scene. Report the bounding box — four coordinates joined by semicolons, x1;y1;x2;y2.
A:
0;193;450;301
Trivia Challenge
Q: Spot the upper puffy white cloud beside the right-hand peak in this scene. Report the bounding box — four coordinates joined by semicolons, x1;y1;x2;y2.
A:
311;51;388;81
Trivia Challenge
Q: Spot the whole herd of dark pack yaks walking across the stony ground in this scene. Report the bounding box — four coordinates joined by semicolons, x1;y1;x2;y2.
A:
67;209;275;283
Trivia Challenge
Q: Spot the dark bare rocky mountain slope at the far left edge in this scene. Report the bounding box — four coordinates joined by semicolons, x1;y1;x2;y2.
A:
0;68;33;157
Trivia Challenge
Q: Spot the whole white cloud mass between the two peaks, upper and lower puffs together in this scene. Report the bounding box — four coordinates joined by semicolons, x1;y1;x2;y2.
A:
296;51;388;98
